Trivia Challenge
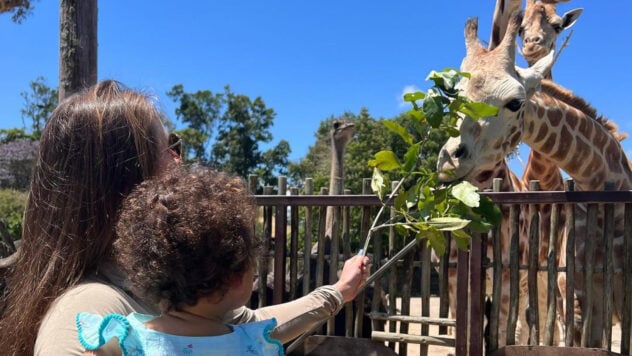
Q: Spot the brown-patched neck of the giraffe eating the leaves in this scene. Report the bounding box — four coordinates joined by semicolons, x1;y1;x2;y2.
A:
523;83;632;190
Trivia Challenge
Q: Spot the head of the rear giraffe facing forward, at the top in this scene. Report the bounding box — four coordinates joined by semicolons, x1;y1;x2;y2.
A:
520;0;583;65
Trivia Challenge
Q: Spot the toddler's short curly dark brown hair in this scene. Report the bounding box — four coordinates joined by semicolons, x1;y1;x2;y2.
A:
114;166;260;312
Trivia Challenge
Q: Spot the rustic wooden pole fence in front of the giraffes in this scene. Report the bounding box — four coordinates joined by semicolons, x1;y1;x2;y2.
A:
251;177;632;355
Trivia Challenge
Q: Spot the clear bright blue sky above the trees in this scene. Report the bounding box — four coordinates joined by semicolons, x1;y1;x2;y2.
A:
0;0;632;177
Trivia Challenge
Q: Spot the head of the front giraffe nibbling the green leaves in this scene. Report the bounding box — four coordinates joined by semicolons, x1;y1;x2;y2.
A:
437;12;553;182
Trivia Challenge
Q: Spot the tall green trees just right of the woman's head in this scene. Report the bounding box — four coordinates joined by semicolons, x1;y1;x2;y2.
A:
167;84;291;184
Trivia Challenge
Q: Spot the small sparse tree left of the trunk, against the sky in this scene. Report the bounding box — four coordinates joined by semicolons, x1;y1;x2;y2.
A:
20;76;59;140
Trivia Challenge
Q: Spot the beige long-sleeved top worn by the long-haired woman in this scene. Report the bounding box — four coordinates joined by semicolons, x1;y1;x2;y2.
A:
35;265;343;355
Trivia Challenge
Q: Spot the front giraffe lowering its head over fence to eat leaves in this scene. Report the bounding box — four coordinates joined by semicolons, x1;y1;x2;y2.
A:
438;13;632;347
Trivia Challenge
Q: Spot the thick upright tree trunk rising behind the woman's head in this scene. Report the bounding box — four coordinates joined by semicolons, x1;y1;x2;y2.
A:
59;0;97;102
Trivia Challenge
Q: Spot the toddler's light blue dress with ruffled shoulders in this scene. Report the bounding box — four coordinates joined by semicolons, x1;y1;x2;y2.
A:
76;313;283;356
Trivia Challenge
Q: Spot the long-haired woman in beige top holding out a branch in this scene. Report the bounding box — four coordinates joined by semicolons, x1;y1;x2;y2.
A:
0;81;368;355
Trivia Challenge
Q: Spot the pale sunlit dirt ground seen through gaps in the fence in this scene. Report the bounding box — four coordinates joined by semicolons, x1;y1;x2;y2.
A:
388;298;621;356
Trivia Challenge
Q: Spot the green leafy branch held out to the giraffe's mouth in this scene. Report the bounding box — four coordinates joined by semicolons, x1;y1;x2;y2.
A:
365;69;500;255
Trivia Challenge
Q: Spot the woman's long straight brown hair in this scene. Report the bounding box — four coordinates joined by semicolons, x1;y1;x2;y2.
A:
0;81;166;355
